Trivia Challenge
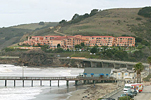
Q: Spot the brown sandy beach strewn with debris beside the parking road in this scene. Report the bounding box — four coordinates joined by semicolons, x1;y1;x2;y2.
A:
67;83;118;100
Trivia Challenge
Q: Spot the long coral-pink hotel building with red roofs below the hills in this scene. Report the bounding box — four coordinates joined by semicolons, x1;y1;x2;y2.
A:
19;35;135;49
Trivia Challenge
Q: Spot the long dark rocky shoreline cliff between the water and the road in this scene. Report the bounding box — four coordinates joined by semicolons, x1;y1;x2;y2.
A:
0;50;87;68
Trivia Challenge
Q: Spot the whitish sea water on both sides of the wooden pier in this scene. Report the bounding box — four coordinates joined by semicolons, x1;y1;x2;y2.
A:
0;64;84;100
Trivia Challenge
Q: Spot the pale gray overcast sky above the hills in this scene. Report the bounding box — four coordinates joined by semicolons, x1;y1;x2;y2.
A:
0;0;151;27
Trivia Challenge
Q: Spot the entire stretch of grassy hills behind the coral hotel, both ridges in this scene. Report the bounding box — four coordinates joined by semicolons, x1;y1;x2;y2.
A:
0;8;151;49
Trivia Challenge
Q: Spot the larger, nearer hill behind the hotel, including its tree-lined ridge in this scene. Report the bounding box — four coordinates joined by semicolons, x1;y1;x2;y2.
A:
30;8;151;42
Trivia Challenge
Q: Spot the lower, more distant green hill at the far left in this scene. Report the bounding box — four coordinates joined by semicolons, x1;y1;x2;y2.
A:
0;22;58;50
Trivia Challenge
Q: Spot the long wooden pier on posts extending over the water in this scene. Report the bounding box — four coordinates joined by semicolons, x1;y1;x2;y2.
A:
0;76;121;87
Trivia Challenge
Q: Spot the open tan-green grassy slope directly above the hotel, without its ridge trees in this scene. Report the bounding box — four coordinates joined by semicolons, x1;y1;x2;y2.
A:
60;8;145;36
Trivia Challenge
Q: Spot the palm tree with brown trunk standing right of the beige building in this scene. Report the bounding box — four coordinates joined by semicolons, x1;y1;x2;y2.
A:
134;62;144;83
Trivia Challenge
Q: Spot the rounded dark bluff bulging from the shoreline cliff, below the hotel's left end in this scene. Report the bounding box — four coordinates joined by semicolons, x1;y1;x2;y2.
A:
19;50;59;66
